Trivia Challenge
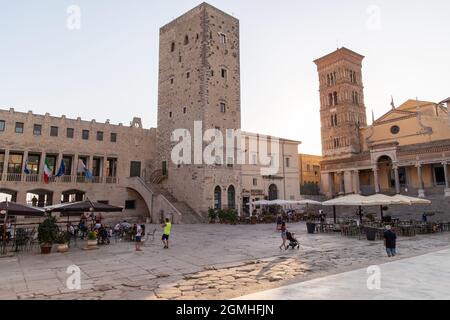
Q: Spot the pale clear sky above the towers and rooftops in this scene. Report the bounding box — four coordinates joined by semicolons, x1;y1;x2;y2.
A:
0;0;450;154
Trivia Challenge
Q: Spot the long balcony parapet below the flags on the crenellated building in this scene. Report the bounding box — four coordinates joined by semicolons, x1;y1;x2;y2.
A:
0;173;119;184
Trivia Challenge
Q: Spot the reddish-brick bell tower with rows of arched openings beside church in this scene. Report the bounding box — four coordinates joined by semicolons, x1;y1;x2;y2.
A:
314;47;367;159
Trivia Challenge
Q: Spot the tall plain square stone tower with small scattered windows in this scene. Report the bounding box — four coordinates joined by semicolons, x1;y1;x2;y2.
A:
158;3;241;215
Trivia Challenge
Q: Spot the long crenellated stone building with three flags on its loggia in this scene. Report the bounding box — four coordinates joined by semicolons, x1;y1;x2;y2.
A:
0;109;156;220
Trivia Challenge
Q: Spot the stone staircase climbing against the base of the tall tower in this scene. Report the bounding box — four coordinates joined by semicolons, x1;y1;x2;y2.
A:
125;177;206;224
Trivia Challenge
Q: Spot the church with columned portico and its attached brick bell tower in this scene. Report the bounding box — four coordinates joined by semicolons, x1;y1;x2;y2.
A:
315;48;450;197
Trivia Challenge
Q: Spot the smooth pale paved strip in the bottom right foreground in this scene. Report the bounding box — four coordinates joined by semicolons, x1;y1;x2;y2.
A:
239;249;450;300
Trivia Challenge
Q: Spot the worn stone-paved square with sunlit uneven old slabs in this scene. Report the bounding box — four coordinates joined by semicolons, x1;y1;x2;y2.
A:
0;223;450;300
